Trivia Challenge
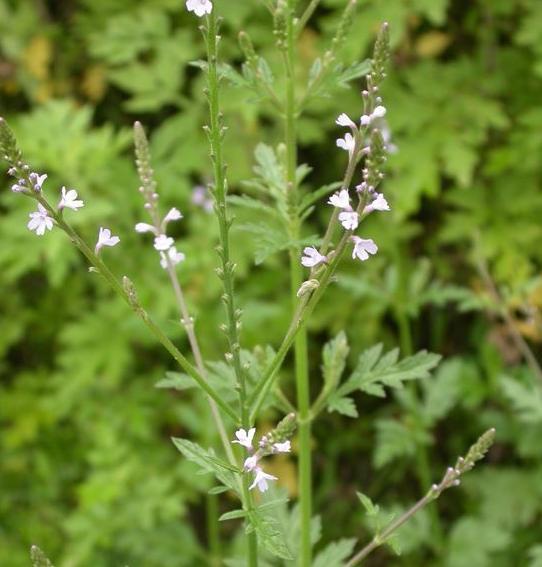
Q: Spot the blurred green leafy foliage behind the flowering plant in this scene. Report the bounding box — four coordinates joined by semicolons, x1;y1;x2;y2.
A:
0;0;542;567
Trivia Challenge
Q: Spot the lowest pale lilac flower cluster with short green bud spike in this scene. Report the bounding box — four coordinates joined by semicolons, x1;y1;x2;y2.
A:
232;414;295;492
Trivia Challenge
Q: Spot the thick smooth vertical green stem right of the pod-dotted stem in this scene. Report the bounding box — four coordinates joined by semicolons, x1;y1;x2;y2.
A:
284;0;312;567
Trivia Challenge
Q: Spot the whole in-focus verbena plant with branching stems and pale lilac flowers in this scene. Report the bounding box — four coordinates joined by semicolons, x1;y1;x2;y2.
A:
0;0;494;567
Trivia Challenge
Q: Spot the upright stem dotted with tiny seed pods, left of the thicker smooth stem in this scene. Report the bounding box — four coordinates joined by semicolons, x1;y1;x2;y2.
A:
207;9;258;567
